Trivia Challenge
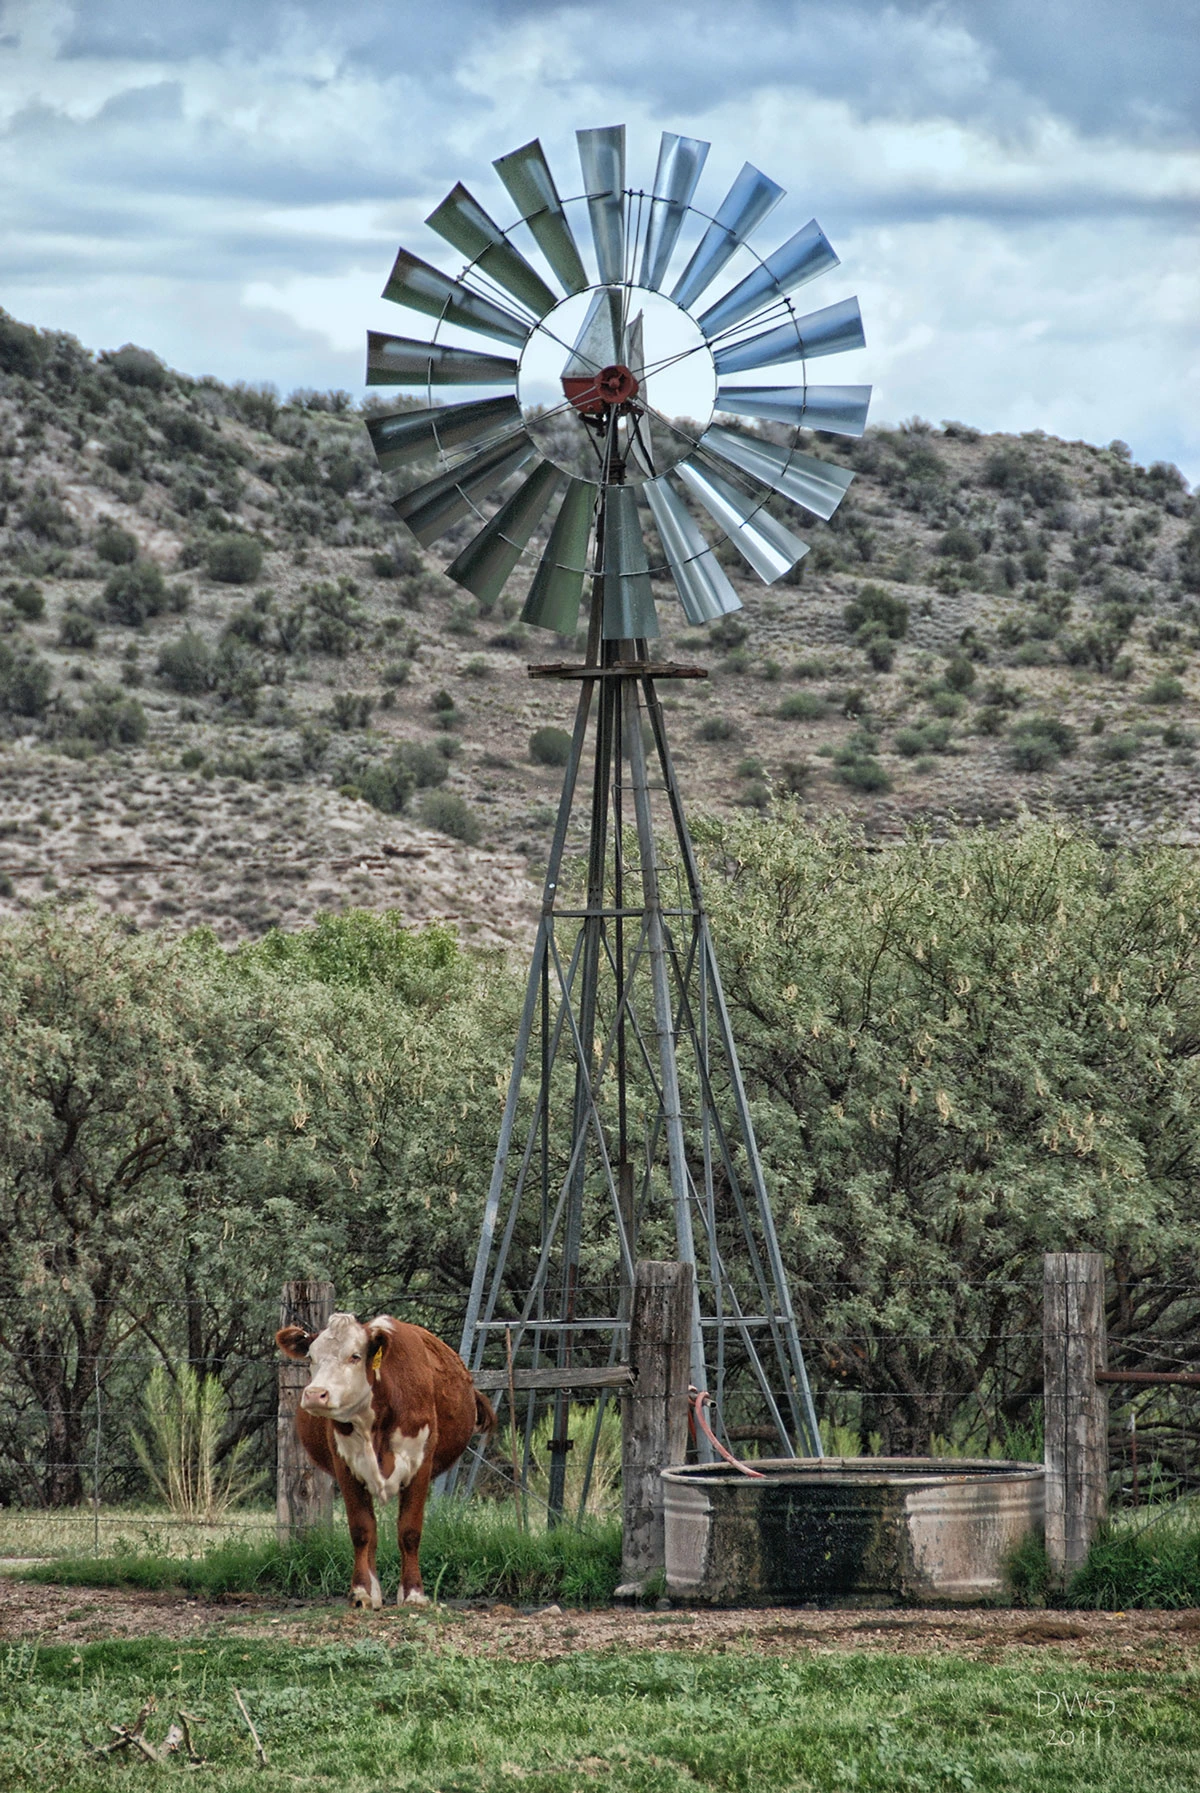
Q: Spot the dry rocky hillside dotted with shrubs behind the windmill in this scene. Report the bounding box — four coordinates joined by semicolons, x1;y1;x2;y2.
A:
0;314;1200;943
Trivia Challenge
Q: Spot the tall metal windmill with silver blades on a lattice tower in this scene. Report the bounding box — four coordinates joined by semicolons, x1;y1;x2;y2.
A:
368;126;870;1513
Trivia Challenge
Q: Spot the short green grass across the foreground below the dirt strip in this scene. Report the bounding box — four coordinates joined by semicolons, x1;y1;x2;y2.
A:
0;1642;1200;1793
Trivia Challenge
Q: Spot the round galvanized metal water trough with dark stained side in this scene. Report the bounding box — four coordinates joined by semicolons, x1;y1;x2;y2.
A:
662;1458;1044;1605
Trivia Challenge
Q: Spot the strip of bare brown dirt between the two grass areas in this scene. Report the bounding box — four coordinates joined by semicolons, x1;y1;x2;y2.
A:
0;1574;1200;1669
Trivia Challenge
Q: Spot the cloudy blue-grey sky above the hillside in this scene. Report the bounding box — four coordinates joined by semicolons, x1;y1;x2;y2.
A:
0;0;1200;482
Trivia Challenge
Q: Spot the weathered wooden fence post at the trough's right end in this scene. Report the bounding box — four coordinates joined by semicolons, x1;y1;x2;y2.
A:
1042;1252;1109;1580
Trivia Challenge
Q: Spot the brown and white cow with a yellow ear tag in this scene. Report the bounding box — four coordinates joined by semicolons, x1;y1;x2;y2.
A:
274;1314;495;1607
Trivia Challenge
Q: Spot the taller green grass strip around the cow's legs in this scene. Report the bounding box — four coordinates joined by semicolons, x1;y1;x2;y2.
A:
27;1501;621;1605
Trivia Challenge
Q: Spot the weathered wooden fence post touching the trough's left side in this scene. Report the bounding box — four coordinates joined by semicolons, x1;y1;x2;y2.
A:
617;1259;692;1598
